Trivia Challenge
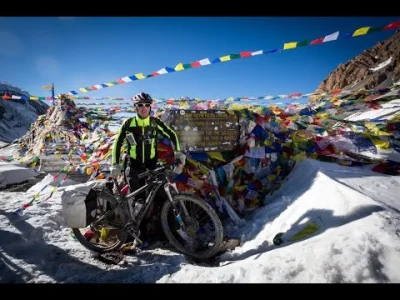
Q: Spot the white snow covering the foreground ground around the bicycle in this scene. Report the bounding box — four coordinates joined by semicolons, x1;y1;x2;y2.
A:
0;159;400;283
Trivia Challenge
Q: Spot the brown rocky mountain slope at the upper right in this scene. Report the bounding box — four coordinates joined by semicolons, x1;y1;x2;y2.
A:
315;30;400;93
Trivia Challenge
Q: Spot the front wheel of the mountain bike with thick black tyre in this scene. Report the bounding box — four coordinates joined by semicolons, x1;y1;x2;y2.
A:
161;194;224;260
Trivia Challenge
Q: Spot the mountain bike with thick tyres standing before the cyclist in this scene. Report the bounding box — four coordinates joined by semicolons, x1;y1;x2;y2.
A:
72;157;224;260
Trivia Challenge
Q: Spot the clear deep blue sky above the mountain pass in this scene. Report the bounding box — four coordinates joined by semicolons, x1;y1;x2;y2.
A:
0;17;400;104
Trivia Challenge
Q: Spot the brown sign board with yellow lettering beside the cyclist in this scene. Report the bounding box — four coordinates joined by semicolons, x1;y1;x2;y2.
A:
170;110;240;151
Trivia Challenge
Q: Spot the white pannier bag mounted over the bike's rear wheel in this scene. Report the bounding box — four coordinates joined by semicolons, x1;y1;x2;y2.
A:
61;180;107;228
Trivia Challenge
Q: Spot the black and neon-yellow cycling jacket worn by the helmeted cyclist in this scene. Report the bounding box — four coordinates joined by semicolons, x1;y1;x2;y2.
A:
112;116;180;165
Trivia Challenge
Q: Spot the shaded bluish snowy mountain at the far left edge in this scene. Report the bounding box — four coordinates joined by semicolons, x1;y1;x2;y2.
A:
0;81;49;144
